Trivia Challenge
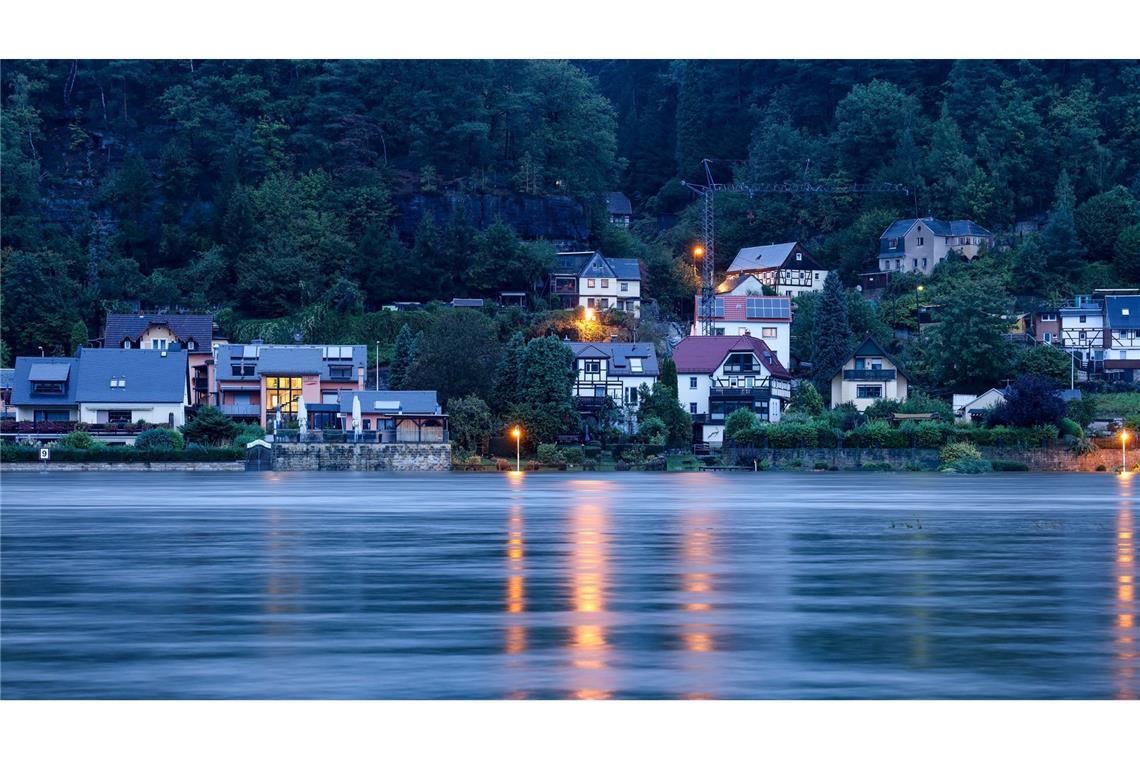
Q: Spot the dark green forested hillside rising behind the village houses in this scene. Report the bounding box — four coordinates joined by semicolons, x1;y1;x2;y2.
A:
2;60;1140;362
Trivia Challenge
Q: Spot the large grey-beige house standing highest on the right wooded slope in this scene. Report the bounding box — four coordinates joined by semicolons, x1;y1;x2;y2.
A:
879;216;994;275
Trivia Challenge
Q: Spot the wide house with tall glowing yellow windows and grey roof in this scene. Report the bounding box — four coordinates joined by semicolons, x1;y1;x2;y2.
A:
209;343;368;427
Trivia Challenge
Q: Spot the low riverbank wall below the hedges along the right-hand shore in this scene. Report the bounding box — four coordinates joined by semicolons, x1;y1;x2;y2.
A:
730;446;1121;473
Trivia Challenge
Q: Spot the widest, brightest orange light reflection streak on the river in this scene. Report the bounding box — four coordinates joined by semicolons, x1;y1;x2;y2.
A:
570;504;612;700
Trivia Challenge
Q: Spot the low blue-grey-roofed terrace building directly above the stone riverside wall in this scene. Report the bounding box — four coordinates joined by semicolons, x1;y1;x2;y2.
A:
337;391;448;443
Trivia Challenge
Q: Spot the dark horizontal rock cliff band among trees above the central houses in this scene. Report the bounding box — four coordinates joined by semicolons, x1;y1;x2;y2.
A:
394;193;589;246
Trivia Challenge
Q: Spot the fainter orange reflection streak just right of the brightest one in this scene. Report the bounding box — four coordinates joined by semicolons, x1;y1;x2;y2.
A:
681;509;716;700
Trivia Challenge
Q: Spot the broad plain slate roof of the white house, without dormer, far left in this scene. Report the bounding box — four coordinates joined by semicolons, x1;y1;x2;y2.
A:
75;349;187;403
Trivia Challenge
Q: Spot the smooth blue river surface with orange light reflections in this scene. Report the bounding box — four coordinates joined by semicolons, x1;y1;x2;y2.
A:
0;473;1140;698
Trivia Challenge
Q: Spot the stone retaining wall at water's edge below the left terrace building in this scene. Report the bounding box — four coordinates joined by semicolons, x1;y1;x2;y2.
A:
274;443;451;472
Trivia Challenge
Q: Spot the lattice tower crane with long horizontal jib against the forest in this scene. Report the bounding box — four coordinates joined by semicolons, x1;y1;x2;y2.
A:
681;158;911;335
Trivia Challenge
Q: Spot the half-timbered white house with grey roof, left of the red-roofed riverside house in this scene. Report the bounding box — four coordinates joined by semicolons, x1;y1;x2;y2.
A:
567;342;660;433
